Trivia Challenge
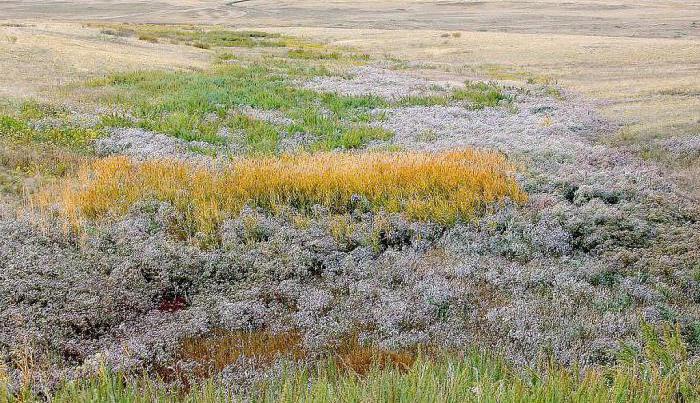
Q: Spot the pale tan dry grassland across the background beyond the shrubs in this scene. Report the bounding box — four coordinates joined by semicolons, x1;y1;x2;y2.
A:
0;1;700;150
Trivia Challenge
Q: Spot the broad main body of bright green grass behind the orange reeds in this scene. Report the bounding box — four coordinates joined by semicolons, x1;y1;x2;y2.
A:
85;60;390;153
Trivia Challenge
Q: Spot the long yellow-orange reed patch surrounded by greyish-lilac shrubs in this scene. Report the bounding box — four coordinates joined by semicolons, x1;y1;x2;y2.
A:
31;149;526;234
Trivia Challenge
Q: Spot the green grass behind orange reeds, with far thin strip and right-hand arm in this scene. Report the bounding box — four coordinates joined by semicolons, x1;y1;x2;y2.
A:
71;34;508;154
